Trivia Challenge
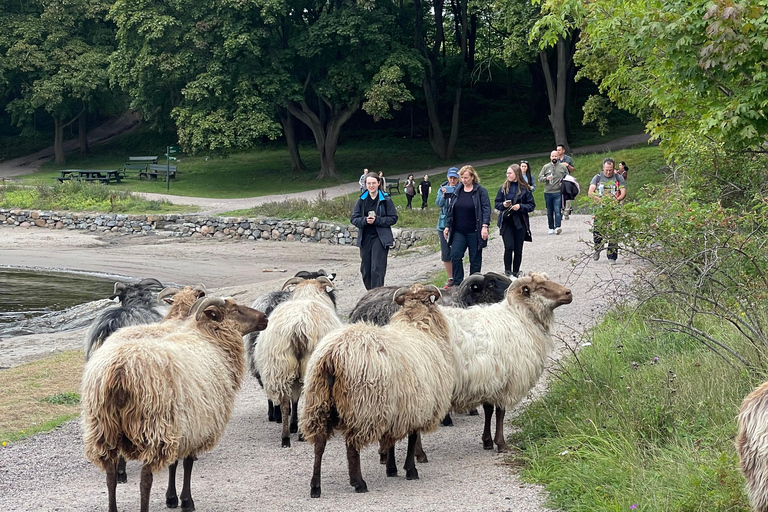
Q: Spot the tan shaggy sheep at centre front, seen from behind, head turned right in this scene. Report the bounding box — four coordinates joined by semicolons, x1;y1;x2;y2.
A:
299;284;454;498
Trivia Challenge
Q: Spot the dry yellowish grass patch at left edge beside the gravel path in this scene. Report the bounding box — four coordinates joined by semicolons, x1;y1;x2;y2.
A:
0;350;85;442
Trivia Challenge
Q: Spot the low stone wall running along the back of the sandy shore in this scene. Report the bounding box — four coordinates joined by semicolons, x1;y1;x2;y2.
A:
0;209;437;249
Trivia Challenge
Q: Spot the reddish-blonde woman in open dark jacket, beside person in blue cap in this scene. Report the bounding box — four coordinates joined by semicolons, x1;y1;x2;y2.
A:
443;165;491;286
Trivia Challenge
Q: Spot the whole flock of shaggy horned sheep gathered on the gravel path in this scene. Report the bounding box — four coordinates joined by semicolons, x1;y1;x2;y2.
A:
82;271;572;512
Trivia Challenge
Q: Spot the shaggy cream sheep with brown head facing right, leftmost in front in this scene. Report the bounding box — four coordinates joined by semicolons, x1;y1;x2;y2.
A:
81;297;267;512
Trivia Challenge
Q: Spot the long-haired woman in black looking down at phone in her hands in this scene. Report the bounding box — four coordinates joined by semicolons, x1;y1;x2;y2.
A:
494;164;536;277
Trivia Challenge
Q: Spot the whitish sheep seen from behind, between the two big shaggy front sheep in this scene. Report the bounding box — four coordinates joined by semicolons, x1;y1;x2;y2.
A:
254;276;341;448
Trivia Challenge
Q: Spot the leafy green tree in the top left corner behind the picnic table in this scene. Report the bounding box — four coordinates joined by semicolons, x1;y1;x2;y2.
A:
0;0;114;163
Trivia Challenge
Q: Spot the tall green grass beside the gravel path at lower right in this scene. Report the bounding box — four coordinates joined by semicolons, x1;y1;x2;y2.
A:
512;301;757;512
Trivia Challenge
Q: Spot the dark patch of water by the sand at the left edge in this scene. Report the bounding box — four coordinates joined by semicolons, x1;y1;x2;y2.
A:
0;268;115;324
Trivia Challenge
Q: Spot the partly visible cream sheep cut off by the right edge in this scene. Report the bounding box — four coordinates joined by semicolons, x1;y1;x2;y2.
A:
736;382;768;512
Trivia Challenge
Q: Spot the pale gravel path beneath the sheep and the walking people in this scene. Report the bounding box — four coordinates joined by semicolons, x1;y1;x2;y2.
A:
0;215;633;512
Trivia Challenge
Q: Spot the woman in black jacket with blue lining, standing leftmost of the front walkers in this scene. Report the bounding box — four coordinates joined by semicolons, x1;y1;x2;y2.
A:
349;173;397;290
